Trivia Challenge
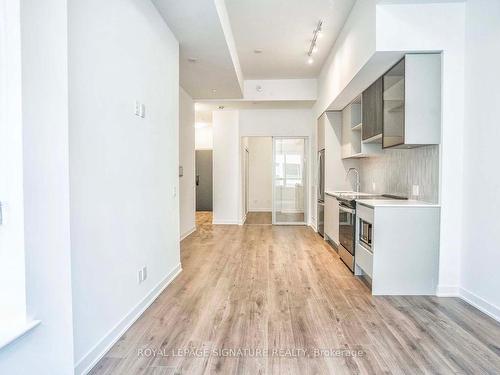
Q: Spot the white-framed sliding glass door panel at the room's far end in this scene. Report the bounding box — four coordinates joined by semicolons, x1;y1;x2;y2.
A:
273;137;307;224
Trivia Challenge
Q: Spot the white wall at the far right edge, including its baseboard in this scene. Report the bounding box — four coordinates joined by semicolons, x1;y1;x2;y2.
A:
461;0;500;320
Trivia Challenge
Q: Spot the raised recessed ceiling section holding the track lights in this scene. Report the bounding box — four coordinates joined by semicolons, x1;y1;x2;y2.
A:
226;0;356;79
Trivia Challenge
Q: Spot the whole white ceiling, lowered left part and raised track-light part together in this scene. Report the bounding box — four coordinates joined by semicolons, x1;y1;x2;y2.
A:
152;0;355;100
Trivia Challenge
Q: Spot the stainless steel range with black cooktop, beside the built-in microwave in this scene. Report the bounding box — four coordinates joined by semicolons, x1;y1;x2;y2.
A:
336;193;407;272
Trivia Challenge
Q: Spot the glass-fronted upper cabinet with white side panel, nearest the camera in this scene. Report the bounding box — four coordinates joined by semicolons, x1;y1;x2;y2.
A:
382;54;441;148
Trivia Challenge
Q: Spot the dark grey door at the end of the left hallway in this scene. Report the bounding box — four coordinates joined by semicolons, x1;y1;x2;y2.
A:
195;150;213;211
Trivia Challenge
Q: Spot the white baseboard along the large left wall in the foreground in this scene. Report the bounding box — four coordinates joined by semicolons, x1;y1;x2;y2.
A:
75;263;182;375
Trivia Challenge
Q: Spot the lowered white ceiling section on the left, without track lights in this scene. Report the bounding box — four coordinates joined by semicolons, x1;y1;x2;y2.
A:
153;0;242;99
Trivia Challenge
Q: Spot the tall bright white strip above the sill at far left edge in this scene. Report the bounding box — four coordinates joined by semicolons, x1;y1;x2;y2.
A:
0;0;26;322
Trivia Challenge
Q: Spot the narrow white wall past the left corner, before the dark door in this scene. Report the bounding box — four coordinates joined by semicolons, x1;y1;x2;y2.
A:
179;87;196;239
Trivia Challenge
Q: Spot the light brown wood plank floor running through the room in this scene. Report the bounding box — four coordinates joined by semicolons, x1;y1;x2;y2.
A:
92;218;500;375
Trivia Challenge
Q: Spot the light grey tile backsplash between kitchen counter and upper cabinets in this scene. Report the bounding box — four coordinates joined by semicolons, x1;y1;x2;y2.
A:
360;145;439;203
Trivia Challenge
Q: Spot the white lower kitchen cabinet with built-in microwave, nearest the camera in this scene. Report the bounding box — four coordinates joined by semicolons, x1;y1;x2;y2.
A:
354;200;440;295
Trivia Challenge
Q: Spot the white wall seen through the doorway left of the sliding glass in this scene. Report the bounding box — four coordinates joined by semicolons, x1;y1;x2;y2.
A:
248;137;273;212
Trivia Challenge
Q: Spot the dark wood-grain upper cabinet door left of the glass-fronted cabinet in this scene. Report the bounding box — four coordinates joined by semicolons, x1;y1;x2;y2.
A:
362;77;384;143
